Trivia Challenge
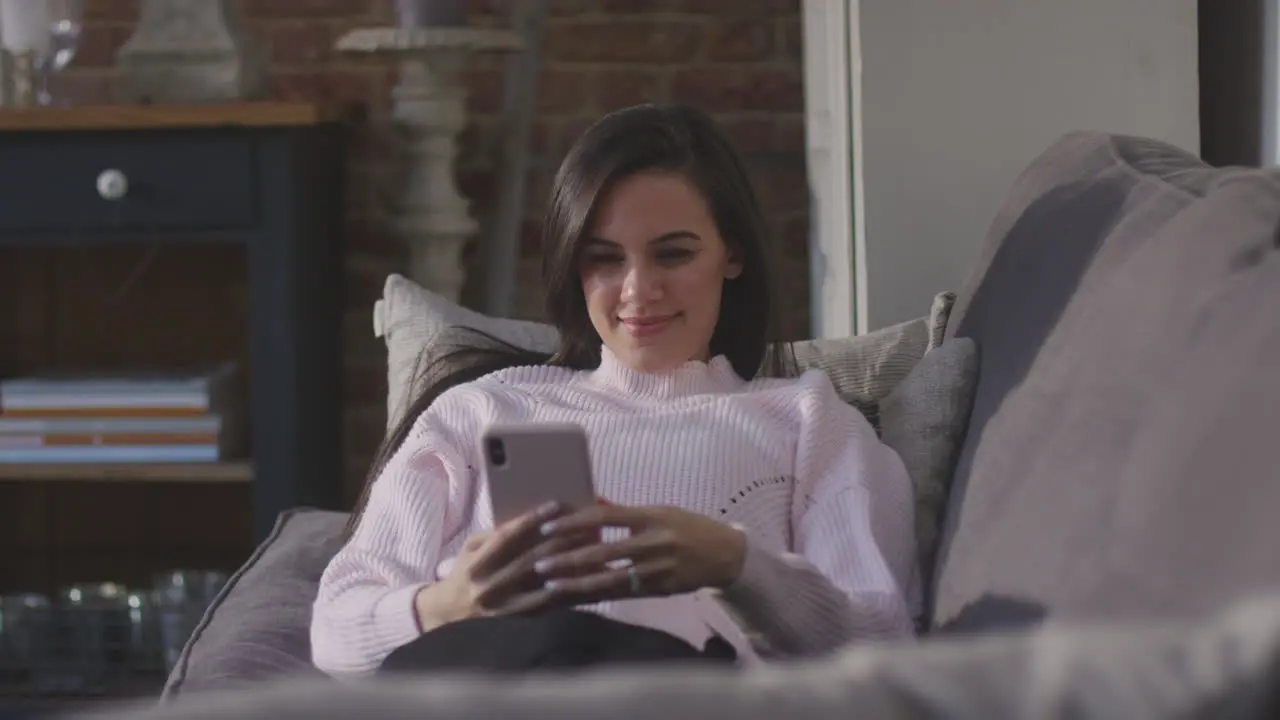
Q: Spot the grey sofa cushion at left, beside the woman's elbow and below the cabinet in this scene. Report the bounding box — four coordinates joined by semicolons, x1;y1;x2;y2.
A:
164;509;347;700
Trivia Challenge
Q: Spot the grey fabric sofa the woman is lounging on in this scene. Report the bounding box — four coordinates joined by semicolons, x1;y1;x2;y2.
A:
70;132;1280;720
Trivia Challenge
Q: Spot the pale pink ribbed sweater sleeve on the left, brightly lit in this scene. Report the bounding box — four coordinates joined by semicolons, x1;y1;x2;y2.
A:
311;396;471;675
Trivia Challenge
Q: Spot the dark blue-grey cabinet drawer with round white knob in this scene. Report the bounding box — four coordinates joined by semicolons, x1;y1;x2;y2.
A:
0;131;256;233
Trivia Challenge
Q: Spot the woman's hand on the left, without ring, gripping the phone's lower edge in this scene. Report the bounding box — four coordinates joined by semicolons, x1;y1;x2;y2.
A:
413;502;598;633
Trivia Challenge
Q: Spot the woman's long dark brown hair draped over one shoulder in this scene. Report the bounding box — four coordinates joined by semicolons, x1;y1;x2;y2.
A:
347;105;795;533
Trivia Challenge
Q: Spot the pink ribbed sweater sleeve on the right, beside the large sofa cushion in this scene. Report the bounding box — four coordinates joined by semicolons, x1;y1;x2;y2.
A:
721;368;915;656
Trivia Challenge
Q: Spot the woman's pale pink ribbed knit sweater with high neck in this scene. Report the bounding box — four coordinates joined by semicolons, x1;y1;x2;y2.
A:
311;350;916;675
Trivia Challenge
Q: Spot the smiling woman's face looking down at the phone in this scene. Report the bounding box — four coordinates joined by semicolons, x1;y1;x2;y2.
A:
580;172;742;373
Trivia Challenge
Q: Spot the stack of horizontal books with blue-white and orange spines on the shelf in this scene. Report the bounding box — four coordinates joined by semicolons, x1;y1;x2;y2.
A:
0;365;244;464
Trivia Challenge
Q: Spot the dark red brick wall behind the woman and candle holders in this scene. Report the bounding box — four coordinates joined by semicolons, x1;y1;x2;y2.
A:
67;0;809;499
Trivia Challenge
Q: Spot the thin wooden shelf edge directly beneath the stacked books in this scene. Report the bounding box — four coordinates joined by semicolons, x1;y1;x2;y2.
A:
0;460;253;483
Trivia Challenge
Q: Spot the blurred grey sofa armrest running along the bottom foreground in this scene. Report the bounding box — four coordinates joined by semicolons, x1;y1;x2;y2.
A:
92;597;1280;720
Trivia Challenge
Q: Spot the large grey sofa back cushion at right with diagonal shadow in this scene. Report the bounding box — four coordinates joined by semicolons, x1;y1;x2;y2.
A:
933;133;1280;629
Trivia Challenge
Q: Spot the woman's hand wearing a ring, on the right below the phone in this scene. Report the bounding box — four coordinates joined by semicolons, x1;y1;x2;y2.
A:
536;503;746;605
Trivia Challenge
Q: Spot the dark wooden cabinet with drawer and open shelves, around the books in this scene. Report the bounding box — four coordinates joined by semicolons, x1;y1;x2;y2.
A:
0;102;348;676
